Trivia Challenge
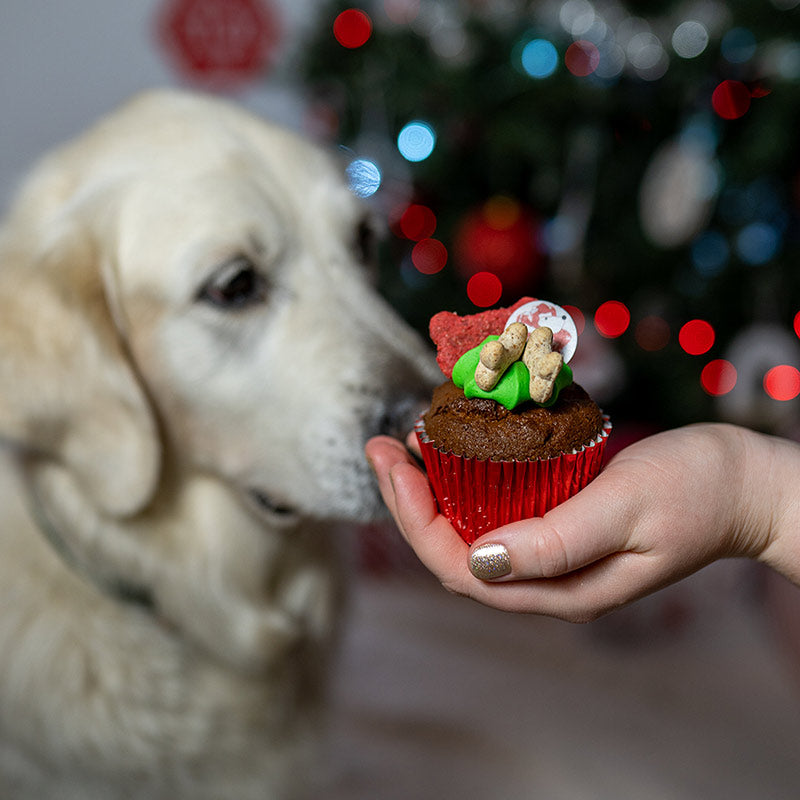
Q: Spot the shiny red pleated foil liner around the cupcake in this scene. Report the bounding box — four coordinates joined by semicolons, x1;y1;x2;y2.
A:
414;416;611;544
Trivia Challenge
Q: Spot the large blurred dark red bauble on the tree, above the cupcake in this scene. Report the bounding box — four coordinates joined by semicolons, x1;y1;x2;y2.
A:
455;197;543;295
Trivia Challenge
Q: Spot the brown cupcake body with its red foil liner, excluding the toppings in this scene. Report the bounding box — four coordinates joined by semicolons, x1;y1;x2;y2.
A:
415;304;611;544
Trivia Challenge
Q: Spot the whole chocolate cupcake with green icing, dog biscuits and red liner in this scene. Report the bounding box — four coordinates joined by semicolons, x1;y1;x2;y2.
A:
415;297;611;544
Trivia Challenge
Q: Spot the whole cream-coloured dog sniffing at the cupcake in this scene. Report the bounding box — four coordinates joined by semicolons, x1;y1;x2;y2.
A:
0;90;439;800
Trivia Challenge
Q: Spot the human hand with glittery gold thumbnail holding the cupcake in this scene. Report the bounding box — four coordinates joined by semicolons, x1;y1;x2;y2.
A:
367;424;800;622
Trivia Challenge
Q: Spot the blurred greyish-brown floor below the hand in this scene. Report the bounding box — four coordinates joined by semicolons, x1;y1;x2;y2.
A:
325;536;800;800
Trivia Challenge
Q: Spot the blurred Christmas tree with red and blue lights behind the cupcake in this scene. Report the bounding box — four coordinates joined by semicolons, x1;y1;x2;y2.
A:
302;0;800;432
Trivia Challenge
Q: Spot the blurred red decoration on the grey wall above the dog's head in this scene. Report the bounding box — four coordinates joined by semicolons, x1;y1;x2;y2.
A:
158;0;281;89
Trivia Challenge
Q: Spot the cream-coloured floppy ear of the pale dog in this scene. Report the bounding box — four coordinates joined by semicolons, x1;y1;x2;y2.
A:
0;219;161;516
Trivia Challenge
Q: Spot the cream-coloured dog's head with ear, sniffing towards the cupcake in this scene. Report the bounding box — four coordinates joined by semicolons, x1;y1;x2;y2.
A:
0;93;437;521
